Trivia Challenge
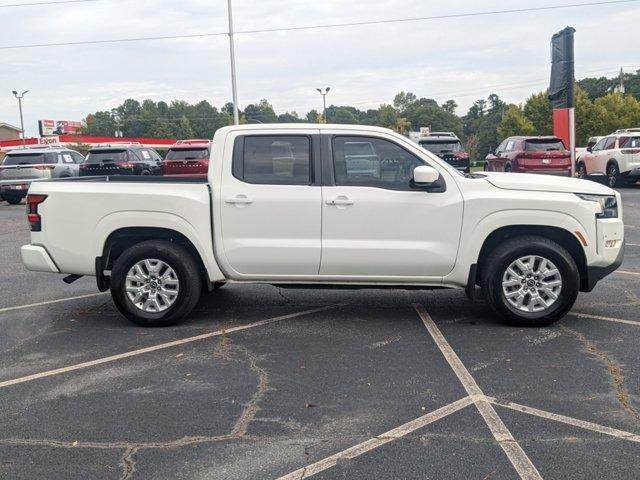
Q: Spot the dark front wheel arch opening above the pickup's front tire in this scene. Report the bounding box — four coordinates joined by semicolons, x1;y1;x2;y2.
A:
475;225;588;291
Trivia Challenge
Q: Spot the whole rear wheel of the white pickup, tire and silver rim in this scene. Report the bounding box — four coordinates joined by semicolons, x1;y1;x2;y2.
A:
111;240;202;327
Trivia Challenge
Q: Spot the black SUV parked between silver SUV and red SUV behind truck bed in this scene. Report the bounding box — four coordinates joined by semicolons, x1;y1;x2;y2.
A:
80;143;162;177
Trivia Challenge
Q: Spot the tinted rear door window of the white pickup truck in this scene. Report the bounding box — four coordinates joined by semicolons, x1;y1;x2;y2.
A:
233;135;312;185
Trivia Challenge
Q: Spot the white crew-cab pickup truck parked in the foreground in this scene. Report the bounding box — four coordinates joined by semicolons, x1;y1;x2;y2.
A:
22;124;624;326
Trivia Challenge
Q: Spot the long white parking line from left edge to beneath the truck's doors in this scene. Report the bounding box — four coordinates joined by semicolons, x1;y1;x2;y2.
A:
0;304;344;388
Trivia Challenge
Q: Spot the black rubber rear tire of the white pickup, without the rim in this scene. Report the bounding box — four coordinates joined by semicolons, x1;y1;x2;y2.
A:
111;240;202;327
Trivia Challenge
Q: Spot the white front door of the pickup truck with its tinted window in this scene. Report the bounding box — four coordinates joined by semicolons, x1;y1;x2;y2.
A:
320;136;463;277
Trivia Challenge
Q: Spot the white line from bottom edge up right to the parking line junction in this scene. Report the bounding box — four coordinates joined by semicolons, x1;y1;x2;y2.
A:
278;397;473;480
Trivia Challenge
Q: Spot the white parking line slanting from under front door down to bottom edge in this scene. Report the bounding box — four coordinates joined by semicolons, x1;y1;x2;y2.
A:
414;304;542;480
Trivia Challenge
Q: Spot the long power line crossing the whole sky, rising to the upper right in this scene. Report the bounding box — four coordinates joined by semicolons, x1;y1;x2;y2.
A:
0;0;640;50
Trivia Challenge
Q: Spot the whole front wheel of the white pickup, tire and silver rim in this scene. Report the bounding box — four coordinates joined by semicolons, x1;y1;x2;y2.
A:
481;236;580;327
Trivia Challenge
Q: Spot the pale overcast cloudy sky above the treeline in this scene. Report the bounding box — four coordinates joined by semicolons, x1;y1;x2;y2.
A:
0;0;640;134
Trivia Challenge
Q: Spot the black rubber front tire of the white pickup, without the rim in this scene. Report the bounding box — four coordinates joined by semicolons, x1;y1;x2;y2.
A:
481;235;580;327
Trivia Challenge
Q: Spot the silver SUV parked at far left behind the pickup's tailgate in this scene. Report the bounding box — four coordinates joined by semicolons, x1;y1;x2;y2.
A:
0;147;84;205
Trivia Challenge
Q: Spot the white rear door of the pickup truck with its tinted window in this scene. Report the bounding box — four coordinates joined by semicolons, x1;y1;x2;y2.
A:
220;130;322;278
